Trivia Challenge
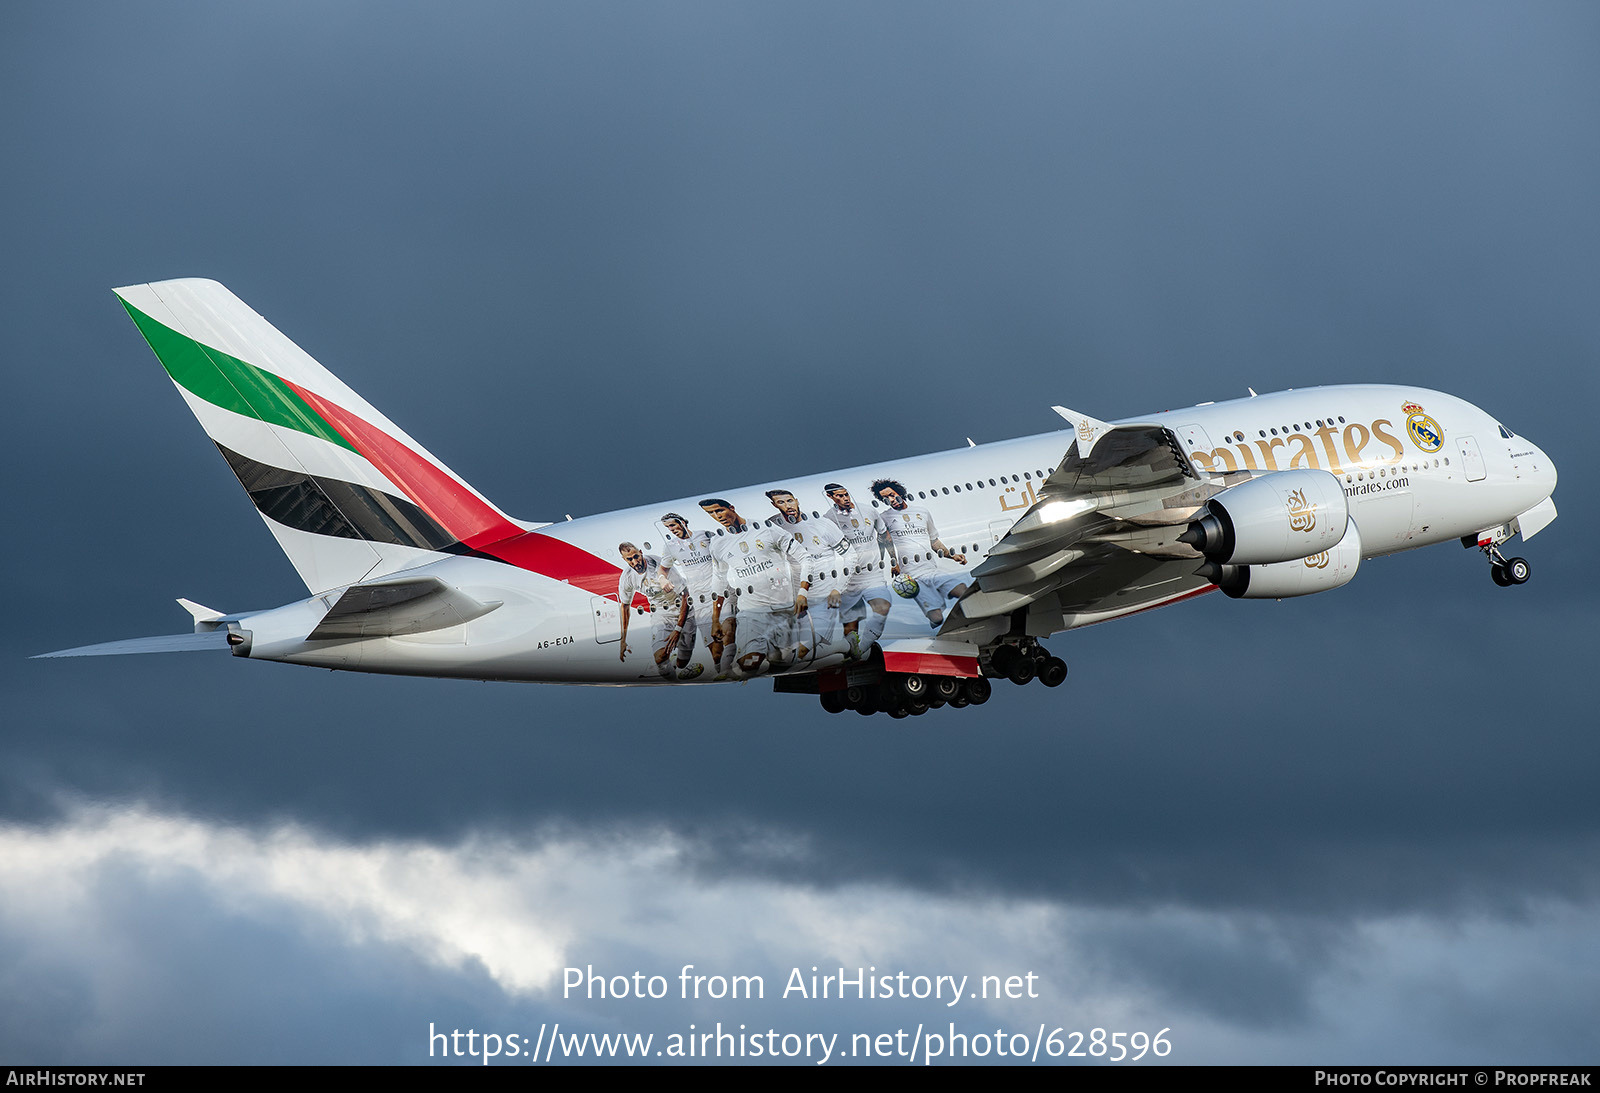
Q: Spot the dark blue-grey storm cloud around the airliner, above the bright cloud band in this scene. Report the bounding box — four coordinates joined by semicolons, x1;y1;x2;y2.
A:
0;5;1600;1062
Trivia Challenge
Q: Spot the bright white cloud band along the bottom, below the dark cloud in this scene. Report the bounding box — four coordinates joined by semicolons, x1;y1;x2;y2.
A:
0;808;1600;1063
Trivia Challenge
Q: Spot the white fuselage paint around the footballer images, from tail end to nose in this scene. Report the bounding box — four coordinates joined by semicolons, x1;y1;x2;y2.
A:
240;386;1557;685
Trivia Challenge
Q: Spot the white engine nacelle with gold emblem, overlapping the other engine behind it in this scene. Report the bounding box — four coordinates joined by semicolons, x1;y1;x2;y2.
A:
1178;470;1350;565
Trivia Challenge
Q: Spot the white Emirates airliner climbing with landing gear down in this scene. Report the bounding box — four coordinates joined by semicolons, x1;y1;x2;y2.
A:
46;280;1555;717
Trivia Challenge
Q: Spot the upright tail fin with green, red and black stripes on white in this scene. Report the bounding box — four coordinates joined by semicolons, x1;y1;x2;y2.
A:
115;278;525;595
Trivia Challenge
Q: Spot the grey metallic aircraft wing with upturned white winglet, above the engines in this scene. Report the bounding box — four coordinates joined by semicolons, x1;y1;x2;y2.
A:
939;419;1222;643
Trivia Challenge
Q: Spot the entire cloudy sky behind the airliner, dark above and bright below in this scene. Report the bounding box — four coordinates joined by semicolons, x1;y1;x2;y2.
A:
0;2;1600;1064
